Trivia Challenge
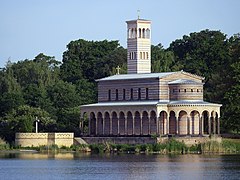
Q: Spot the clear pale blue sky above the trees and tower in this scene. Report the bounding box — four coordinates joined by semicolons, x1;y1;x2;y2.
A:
0;0;240;68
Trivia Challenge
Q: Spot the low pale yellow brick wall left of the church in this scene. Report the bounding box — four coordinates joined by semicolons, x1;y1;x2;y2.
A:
15;133;74;147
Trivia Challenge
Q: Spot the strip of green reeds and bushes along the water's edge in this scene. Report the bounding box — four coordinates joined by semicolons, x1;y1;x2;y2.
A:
0;139;240;154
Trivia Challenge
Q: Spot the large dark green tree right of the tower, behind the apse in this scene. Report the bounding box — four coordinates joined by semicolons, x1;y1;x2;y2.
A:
168;30;230;103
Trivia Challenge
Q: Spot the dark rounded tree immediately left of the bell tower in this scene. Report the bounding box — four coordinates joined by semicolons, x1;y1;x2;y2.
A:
61;39;122;83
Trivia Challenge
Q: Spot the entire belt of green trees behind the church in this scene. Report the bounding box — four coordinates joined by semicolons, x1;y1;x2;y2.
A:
0;29;240;142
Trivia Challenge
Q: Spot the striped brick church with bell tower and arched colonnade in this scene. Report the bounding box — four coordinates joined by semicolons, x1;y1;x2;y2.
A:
81;19;221;137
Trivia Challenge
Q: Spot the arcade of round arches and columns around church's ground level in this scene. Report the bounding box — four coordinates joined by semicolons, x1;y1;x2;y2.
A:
82;110;220;136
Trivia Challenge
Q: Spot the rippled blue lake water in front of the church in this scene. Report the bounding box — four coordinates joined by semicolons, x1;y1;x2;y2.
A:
0;152;240;180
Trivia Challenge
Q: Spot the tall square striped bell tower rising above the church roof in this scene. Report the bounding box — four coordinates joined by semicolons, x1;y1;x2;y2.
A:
126;18;151;74
